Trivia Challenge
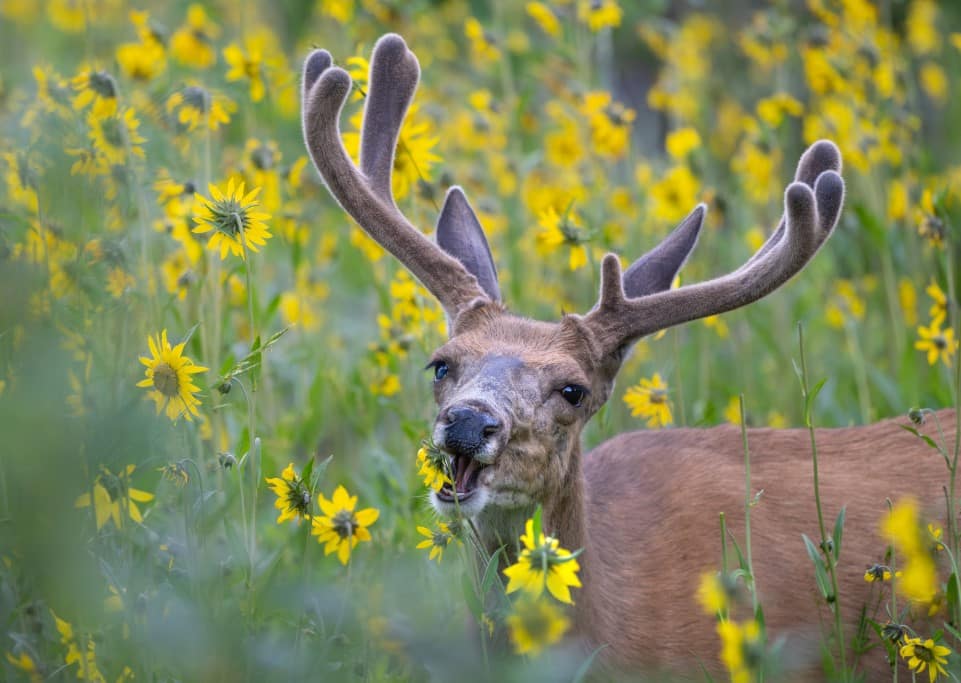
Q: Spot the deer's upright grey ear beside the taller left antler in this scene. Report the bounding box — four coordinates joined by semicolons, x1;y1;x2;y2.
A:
437;185;501;301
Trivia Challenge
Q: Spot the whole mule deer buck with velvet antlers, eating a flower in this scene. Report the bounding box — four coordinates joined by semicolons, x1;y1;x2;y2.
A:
302;35;945;672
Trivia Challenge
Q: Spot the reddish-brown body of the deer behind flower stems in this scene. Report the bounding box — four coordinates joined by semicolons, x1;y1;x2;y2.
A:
581;411;954;672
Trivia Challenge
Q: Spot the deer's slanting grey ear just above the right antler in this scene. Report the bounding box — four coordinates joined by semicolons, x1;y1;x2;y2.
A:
622;204;707;299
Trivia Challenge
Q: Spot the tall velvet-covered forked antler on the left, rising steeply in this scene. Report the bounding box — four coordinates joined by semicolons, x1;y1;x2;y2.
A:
302;34;488;321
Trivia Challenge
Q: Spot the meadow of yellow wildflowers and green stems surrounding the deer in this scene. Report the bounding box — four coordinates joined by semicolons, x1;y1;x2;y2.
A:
0;0;961;683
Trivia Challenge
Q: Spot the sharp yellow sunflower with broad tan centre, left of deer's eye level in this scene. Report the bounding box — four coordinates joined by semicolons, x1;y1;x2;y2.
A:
137;330;207;422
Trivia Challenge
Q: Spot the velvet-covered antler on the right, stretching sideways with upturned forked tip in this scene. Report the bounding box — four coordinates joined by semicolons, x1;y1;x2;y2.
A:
585;143;844;353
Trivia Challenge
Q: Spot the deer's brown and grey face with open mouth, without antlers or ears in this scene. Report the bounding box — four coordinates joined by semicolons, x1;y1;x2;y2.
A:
429;310;610;516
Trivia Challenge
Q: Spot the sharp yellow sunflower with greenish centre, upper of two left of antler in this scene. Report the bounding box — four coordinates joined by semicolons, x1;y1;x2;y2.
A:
193;178;271;260
